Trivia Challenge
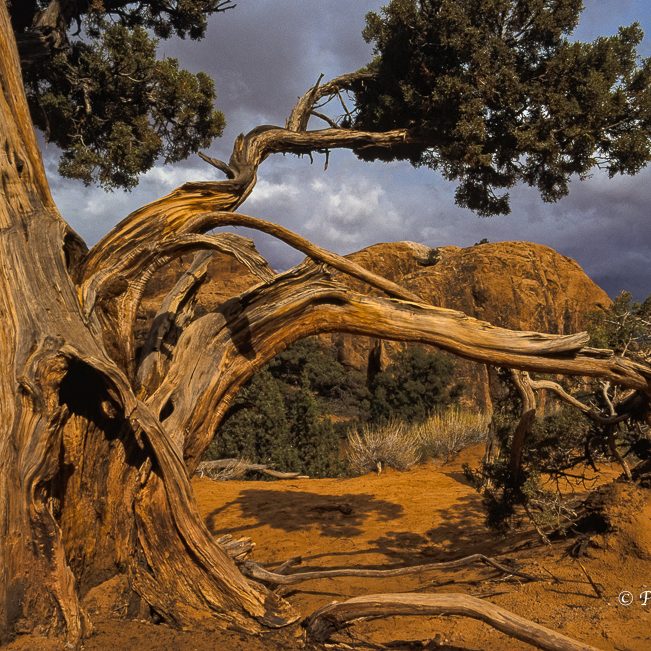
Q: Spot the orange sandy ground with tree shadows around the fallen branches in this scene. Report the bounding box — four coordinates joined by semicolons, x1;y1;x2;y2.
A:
8;449;651;651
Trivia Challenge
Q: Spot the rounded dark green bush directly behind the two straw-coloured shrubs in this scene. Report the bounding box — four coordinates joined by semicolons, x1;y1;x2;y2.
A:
369;346;460;423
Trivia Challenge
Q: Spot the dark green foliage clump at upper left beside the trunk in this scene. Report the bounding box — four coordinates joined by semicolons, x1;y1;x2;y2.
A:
11;0;233;189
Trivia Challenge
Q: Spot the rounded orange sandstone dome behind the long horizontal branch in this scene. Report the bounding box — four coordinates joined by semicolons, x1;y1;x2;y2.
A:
324;242;611;408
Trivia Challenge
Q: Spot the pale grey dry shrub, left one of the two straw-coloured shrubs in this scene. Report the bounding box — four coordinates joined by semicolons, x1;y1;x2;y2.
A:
347;419;420;474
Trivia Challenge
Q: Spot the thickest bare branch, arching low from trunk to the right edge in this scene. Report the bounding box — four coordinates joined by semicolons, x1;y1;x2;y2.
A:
148;264;651;469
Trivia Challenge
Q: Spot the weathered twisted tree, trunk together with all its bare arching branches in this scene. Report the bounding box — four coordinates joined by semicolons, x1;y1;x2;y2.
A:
0;0;651;644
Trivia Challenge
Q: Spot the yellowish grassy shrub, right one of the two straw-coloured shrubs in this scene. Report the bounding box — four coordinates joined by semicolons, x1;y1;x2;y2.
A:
417;406;490;460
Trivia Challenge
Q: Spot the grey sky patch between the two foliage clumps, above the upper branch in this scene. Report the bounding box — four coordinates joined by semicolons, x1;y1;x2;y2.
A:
161;0;381;141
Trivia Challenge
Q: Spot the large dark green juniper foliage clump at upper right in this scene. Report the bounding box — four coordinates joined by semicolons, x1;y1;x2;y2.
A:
355;0;651;215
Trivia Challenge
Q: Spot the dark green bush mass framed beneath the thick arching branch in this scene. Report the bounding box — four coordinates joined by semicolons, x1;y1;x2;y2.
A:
207;338;458;477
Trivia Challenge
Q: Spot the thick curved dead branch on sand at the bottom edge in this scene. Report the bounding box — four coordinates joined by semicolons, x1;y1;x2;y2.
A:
304;593;596;651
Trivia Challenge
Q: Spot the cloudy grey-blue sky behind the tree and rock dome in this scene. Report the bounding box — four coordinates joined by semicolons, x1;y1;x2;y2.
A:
45;0;651;298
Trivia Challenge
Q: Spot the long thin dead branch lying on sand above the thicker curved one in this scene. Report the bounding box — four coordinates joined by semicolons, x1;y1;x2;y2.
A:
241;554;542;585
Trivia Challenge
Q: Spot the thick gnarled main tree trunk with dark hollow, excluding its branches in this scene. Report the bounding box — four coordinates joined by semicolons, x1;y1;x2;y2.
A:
0;2;295;644
